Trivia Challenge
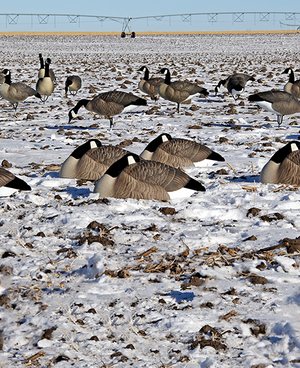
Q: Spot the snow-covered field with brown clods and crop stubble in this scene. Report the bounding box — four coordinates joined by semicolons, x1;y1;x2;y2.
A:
0;34;300;368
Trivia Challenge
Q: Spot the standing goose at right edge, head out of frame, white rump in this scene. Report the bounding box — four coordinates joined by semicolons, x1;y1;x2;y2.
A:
248;90;300;125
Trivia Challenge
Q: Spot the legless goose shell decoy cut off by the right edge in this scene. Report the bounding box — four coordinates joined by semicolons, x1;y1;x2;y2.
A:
259;141;300;185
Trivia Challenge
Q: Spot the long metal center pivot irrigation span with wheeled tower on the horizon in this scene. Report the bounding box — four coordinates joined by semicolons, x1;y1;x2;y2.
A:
0;12;300;38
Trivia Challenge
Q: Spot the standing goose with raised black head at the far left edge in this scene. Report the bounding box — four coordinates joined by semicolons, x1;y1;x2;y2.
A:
0;69;42;112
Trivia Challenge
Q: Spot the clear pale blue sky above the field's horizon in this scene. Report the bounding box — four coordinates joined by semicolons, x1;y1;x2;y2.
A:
0;0;300;32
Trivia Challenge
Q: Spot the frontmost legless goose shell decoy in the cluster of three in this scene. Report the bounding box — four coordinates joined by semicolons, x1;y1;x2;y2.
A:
94;153;205;201
